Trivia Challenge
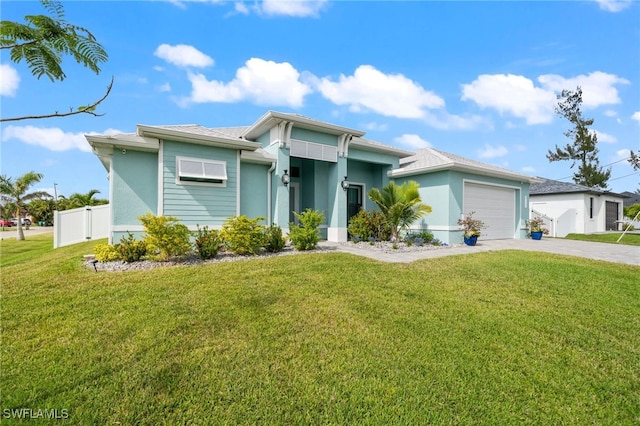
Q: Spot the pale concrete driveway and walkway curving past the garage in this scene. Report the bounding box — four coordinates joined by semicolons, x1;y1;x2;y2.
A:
322;237;640;266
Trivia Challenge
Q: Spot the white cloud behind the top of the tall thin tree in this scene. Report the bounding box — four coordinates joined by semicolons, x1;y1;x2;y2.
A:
538;71;629;108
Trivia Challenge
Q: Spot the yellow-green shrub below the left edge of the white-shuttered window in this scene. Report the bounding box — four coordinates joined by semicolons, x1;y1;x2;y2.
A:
138;213;191;260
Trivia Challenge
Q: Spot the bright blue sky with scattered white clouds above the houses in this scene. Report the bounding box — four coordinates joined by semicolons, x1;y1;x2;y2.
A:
0;0;640;202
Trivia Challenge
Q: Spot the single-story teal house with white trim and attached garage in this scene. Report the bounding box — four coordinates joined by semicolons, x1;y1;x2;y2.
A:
86;111;536;244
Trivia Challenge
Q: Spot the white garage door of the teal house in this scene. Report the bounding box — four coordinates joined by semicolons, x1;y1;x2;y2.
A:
463;183;516;240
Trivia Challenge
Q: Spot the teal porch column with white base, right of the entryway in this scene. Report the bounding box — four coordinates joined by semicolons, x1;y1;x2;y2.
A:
327;157;348;242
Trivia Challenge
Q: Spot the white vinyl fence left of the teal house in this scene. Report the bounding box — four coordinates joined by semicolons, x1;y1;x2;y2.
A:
53;204;109;249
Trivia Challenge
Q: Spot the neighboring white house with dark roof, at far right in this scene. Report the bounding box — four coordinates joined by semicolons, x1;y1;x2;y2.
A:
529;178;625;237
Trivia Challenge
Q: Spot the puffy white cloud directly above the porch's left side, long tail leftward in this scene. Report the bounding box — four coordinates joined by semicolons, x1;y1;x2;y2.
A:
185;58;311;107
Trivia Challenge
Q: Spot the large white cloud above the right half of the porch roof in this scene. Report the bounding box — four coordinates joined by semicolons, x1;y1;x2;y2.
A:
318;65;444;118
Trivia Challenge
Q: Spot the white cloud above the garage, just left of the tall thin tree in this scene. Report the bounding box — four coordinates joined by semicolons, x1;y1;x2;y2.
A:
462;74;556;124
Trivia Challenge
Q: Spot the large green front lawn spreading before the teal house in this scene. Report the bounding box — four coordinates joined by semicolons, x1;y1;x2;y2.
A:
0;235;640;425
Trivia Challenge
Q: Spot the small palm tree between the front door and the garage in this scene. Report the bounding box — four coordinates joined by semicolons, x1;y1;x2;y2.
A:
368;180;431;241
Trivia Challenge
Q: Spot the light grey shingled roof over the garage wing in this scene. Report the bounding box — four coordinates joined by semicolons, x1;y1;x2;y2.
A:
389;148;538;183
